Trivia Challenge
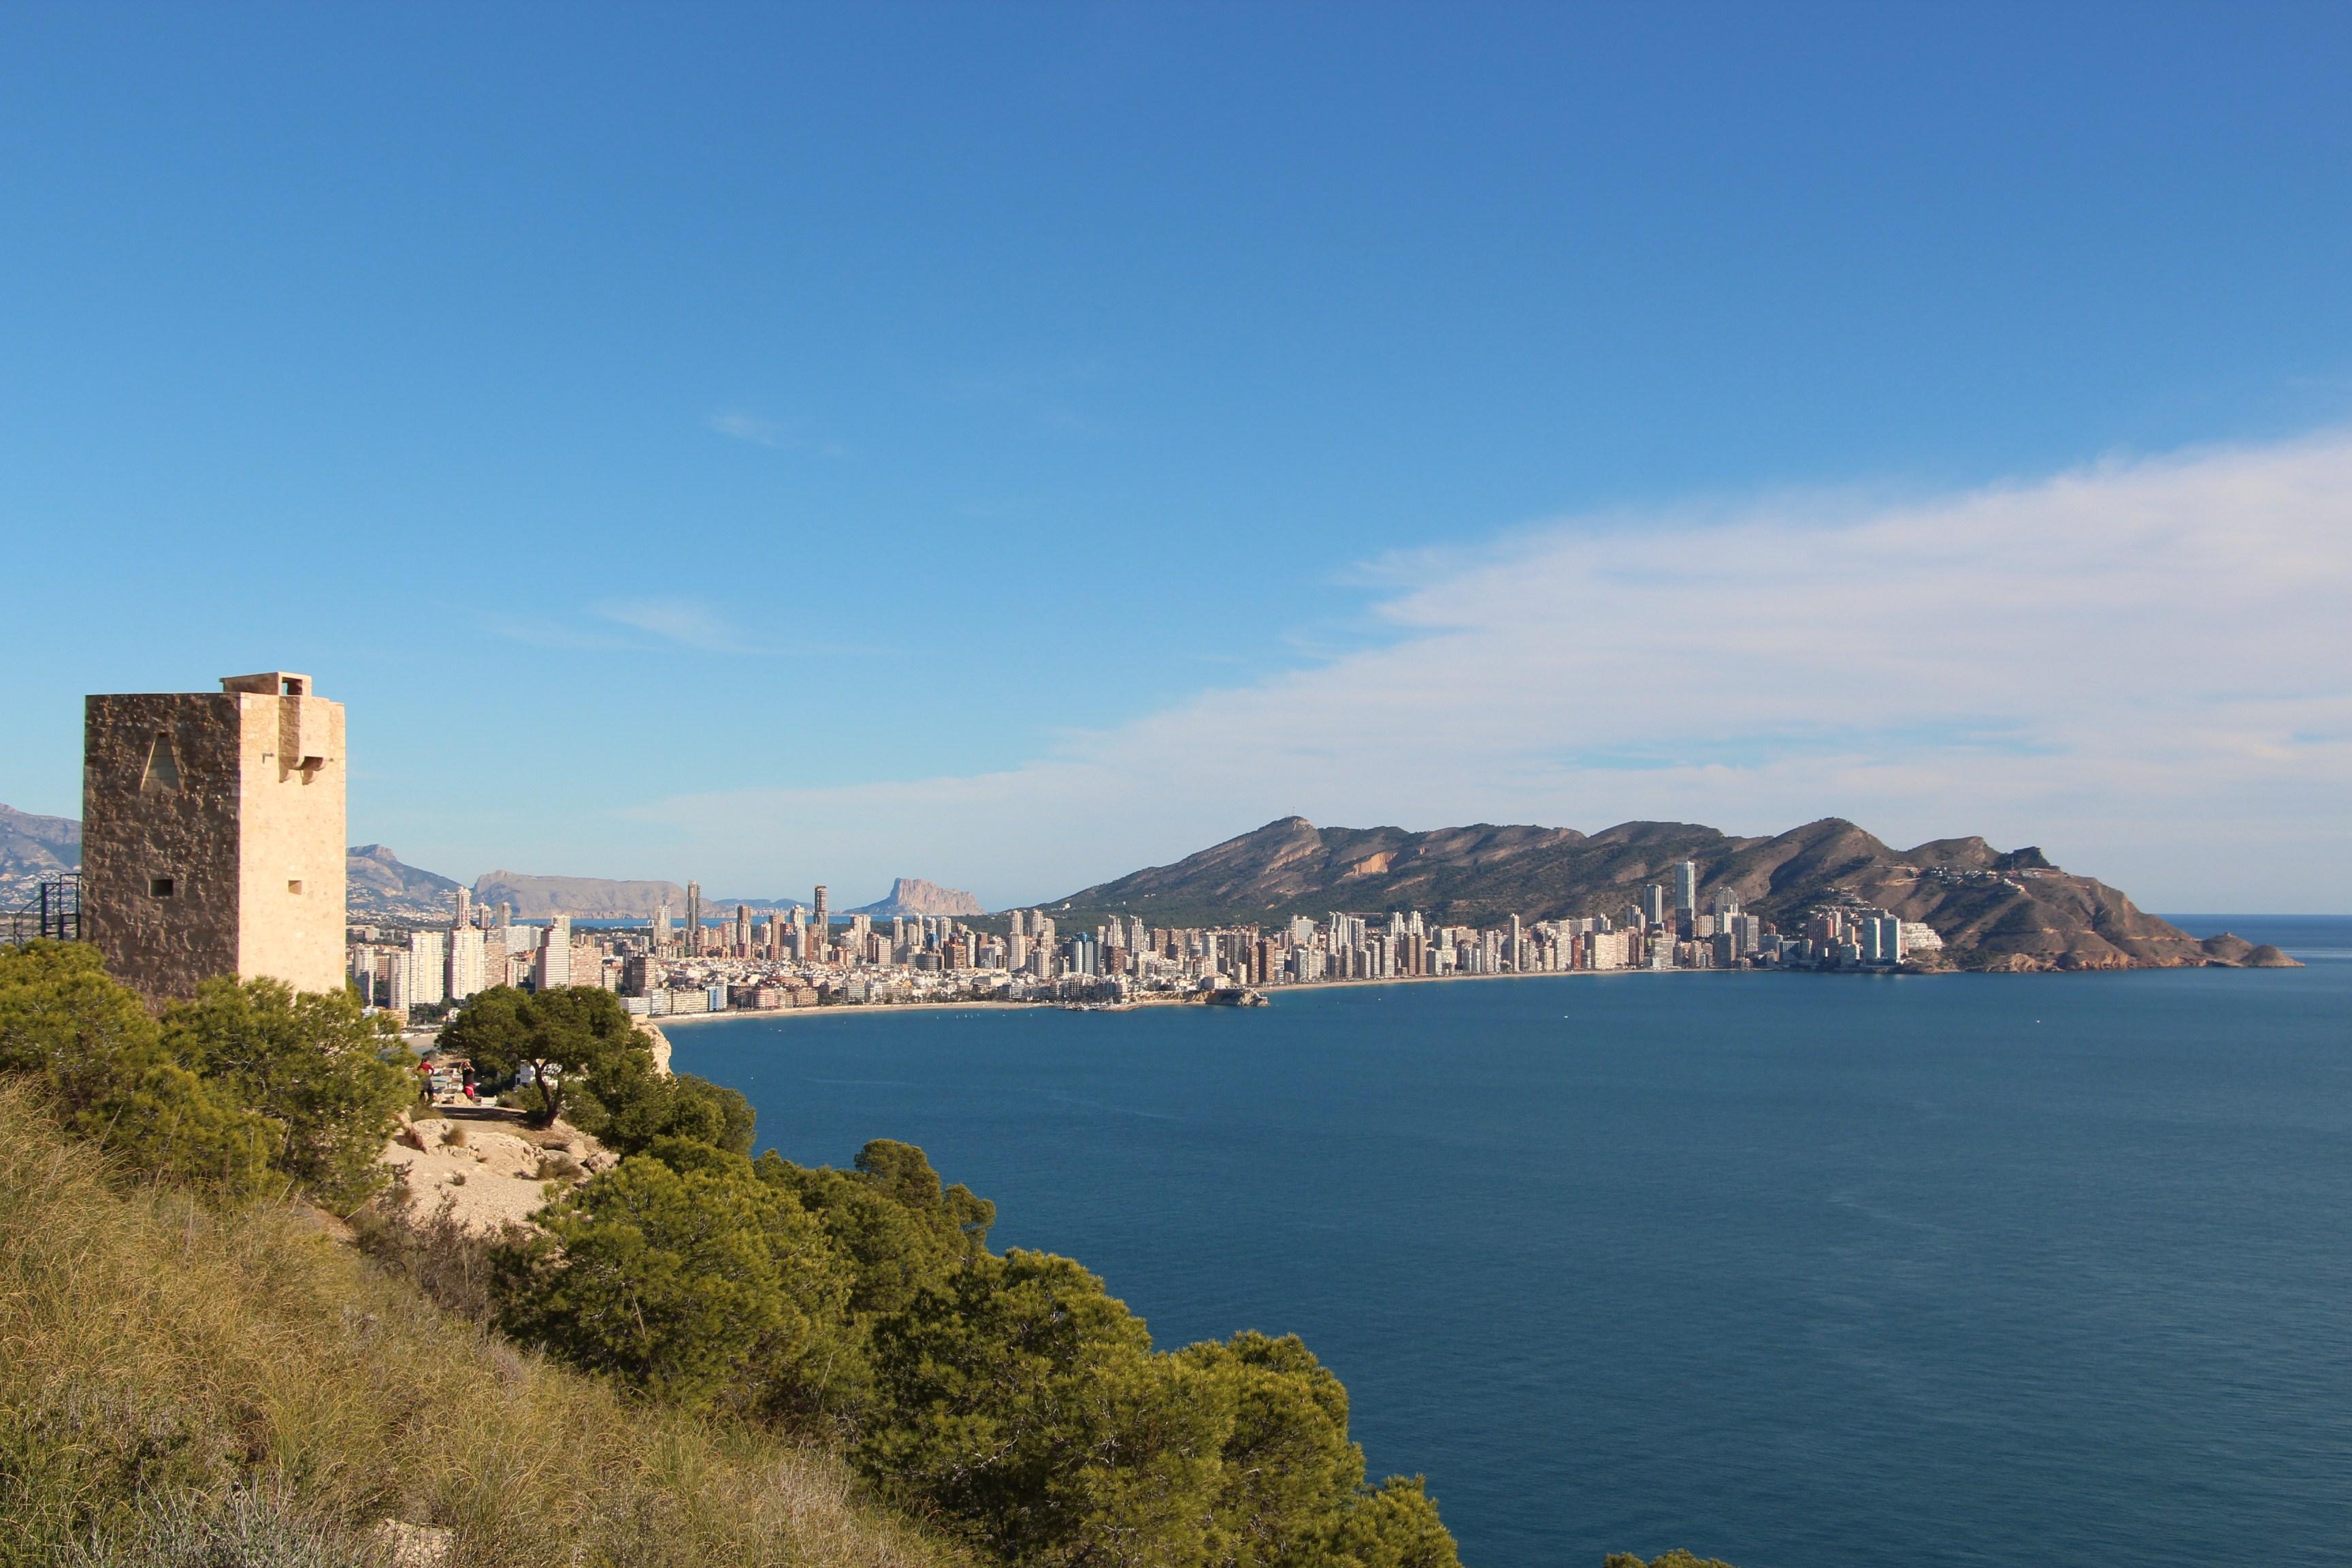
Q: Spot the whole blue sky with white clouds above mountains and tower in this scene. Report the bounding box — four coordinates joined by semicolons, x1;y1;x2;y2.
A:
0;5;2352;910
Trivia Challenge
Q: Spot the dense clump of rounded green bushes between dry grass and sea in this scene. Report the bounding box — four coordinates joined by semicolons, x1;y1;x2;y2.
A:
496;1114;1456;1568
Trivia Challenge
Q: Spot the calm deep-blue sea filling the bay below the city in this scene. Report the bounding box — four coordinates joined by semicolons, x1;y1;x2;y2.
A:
672;917;2352;1568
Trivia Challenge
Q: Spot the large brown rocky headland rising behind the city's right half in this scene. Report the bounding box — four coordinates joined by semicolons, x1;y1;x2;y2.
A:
1051;816;2293;971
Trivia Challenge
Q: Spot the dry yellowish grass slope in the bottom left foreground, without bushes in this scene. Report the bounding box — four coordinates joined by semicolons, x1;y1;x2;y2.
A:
0;1083;955;1568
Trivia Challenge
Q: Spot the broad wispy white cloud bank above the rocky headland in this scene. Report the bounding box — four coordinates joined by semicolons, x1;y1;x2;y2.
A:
625;435;2352;907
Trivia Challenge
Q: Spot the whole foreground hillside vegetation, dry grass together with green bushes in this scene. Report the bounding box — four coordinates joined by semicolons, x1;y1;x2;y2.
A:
0;945;1505;1568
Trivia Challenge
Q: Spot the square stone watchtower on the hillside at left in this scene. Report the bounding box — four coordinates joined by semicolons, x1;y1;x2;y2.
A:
82;670;344;1004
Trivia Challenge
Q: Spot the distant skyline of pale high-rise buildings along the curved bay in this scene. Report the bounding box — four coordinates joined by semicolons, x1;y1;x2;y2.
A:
353;860;1936;1015
